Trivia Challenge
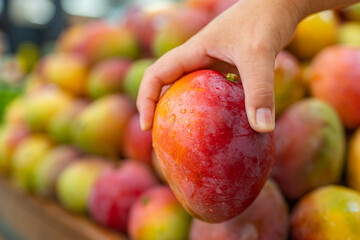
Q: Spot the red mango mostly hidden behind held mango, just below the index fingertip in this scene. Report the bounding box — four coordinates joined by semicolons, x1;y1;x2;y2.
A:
124;114;152;164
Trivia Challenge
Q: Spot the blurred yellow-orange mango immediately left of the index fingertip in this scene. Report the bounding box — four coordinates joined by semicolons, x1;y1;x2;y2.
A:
72;94;136;158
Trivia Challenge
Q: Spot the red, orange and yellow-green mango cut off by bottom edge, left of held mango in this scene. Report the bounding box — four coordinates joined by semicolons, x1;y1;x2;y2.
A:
128;186;191;240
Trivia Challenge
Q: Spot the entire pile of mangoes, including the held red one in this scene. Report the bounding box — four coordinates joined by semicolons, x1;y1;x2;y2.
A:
0;0;360;240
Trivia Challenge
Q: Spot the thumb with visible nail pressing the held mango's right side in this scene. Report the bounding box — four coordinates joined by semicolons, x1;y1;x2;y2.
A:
236;47;275;133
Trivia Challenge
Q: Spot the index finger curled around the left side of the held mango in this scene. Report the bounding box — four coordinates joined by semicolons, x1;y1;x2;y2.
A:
137;42;214;130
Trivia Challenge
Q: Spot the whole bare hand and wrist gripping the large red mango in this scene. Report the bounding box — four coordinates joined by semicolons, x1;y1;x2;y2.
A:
137;0;358;132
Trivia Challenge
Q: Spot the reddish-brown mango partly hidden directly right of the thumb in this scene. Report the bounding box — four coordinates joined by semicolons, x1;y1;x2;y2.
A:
274;51;305;116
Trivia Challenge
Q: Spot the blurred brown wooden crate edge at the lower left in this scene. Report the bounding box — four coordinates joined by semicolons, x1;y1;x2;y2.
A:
0;177;126;240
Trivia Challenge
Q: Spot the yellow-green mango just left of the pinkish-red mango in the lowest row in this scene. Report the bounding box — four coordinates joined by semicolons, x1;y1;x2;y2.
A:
56;157;109;213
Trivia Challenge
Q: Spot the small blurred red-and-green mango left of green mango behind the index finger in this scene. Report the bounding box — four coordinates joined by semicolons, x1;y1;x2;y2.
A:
88;58;131;98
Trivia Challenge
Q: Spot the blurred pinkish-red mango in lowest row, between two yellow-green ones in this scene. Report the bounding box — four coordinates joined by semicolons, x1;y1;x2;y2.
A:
88;160;157;232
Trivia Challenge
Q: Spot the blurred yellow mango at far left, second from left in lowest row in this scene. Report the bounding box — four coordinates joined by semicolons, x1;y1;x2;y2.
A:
11;134;54;192
